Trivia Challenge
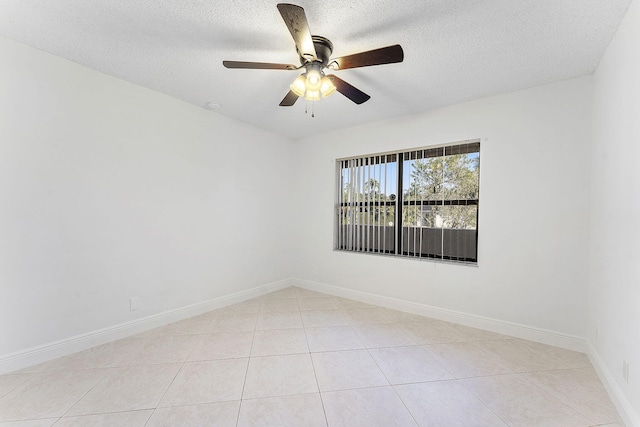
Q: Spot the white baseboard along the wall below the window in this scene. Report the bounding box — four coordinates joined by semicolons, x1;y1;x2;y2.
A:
292;279;587;353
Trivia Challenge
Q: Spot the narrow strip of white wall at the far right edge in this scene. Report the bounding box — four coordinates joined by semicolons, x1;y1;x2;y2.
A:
588;1;640;426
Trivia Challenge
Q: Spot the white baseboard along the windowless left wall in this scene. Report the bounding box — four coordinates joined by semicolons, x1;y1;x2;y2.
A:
0;279;293;375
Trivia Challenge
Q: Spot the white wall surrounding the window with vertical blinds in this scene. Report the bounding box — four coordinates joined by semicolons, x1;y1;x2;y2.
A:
293;77;591;337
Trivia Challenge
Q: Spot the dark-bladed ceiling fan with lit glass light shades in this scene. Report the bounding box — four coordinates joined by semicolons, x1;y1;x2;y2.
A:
222;3;404;107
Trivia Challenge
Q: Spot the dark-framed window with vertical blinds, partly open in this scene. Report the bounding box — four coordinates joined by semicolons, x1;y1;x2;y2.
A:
334;140;480;263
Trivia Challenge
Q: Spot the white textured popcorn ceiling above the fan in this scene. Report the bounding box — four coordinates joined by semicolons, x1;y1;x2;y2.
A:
0;0;632;139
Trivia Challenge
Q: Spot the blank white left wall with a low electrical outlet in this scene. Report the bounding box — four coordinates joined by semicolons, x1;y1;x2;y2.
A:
0;39;292;356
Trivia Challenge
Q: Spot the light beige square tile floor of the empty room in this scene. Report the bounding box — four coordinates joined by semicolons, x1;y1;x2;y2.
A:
0;287;623;427
